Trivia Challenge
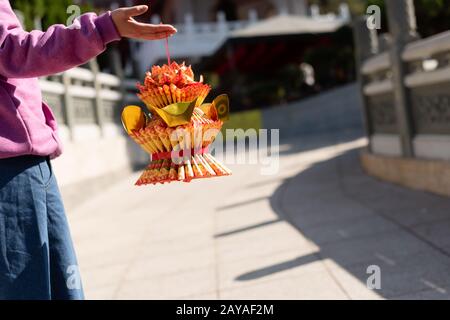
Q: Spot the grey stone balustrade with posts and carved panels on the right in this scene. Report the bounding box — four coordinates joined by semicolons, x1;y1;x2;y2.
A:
355;0;450;160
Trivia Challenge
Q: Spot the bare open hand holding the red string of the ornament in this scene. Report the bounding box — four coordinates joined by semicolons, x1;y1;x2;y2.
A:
111;6;177;40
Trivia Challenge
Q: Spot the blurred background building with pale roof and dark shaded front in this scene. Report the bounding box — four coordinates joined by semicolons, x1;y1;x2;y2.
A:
81;0;354;110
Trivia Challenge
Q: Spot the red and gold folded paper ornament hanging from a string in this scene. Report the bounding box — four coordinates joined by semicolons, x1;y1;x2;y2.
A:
122;62;232;186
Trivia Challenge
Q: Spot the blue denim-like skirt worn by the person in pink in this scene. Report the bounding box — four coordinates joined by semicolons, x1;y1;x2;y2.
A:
0;156;84;300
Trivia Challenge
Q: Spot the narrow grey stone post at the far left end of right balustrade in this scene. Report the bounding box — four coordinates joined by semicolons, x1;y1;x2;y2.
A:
353;17;378;151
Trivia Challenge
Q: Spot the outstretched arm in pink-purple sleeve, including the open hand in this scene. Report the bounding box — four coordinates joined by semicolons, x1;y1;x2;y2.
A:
0;0;176;78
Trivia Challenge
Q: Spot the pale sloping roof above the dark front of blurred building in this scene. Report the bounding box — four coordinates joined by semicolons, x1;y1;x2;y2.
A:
231;15;347;38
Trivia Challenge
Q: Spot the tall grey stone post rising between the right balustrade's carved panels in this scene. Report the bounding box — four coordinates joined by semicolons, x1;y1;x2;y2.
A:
385;0;417;157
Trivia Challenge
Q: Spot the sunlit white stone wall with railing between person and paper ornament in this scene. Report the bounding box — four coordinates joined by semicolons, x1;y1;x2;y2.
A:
40;64;148;188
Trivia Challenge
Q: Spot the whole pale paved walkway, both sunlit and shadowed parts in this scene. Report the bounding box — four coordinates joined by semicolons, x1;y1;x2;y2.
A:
69;135;450;299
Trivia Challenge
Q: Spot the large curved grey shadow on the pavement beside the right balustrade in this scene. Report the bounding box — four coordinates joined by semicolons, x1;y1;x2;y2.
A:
236;151;450;299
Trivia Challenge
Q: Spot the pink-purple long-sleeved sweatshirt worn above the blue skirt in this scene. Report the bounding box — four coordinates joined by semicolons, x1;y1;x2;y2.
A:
0;0;120;159
